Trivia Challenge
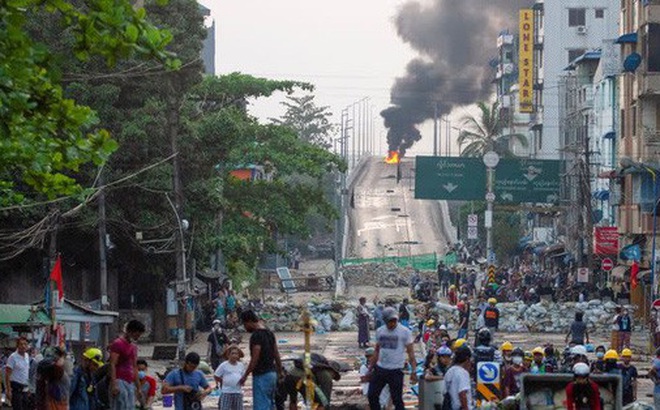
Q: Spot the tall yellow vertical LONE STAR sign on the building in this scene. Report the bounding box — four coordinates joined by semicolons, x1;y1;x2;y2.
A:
518;9;534;113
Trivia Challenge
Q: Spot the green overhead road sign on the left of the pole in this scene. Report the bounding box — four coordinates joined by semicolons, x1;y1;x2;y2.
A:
415;156;486;201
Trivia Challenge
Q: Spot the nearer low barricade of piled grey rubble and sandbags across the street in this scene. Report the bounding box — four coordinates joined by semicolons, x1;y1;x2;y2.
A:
254;296;632;333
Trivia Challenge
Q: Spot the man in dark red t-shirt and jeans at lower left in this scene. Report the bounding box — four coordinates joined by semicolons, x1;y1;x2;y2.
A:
109;320;145;410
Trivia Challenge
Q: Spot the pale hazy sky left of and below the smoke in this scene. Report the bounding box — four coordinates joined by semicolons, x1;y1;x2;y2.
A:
202;0;460;155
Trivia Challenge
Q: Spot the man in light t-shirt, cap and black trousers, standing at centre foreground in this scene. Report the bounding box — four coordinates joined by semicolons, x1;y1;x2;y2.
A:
368;307;417;410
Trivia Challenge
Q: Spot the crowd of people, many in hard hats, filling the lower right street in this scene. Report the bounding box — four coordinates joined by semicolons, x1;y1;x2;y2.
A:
358;289;648;409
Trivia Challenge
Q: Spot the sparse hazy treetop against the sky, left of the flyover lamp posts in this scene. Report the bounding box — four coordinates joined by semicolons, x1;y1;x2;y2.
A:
271;94;334;149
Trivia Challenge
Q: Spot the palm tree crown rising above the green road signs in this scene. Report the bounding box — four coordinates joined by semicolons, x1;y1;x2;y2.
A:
457;102;528;157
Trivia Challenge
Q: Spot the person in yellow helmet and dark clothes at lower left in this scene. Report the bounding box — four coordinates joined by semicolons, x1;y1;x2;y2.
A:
69;347;104;410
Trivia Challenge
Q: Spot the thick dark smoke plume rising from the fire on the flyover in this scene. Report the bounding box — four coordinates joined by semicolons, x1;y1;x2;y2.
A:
380;0;534;156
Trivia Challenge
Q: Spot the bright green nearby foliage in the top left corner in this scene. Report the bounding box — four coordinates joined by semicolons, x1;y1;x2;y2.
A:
0;0;177;205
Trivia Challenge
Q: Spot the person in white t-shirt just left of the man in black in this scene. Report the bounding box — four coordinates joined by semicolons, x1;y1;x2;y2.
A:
214;345;245;410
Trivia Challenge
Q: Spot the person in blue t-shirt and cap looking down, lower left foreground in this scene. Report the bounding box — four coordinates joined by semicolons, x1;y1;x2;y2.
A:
162;352;212;410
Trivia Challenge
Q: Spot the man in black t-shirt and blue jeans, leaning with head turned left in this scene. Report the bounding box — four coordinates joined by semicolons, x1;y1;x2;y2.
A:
239;310;282;410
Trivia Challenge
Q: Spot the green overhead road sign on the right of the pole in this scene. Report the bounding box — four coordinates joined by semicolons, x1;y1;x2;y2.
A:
495;158;561;204
